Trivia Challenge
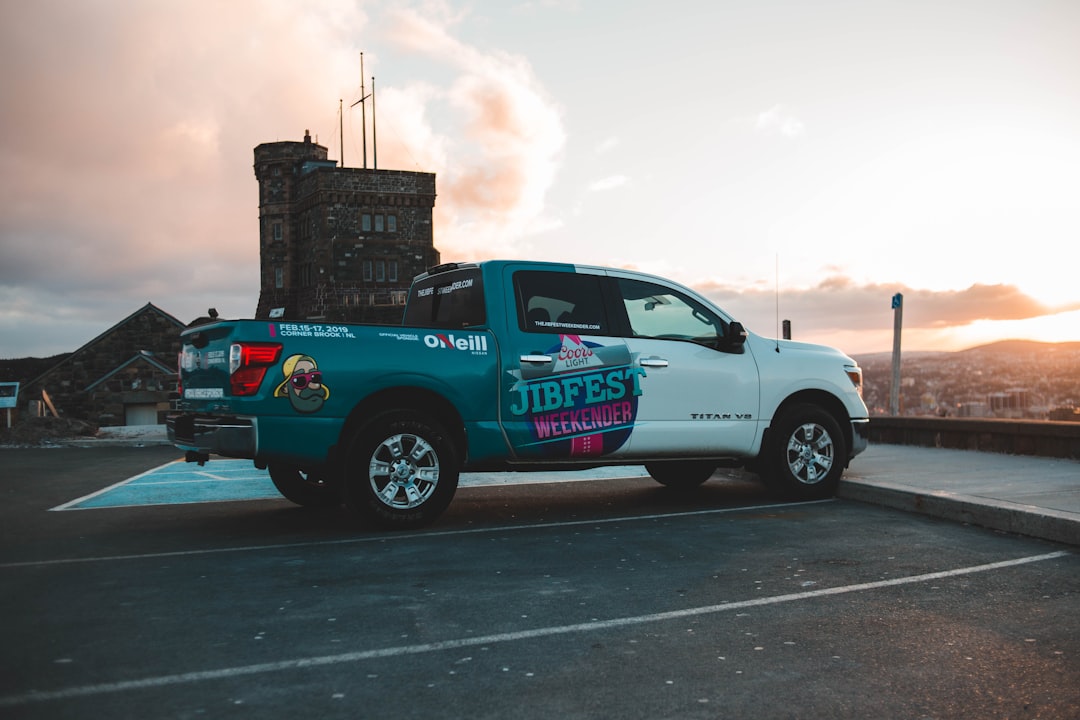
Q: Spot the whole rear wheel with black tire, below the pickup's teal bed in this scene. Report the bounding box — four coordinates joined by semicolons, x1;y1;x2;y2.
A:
341;410;459;530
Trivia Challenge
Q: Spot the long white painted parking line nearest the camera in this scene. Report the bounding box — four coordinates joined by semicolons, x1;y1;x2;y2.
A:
0;551;1069;707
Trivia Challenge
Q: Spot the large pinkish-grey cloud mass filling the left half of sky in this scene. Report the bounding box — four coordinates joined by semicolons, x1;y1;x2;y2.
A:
0;0;565;355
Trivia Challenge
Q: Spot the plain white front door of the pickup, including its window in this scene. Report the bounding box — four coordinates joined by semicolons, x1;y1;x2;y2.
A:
611;272;759;457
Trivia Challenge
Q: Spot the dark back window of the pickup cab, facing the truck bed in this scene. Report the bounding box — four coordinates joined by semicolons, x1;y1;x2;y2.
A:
403;268;486;328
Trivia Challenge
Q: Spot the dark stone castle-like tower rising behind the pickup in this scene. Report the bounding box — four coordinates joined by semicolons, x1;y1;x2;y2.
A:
255;132;440;323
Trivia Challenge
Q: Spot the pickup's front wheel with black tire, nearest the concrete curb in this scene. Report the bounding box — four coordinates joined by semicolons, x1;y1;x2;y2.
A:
762;404;848;500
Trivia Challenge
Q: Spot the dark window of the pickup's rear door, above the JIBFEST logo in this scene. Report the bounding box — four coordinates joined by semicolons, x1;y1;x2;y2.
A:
514;270;611;335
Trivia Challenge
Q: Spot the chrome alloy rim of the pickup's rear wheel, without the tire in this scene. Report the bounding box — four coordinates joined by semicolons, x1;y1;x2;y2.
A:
367;433;440;510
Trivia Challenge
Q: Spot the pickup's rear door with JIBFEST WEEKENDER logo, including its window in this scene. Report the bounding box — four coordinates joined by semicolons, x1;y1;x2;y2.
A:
500;264;642;461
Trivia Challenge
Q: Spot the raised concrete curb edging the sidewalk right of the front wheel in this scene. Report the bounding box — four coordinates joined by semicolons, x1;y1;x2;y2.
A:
837;480;1080;545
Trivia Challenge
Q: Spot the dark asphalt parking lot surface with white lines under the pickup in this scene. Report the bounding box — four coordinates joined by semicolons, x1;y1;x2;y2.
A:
0;447;1080;718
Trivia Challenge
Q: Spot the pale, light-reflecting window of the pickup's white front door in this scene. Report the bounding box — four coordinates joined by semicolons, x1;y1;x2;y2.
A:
619;279;724;347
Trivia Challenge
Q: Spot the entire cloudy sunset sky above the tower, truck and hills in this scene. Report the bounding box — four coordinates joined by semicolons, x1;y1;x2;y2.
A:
0;0;1080;357
